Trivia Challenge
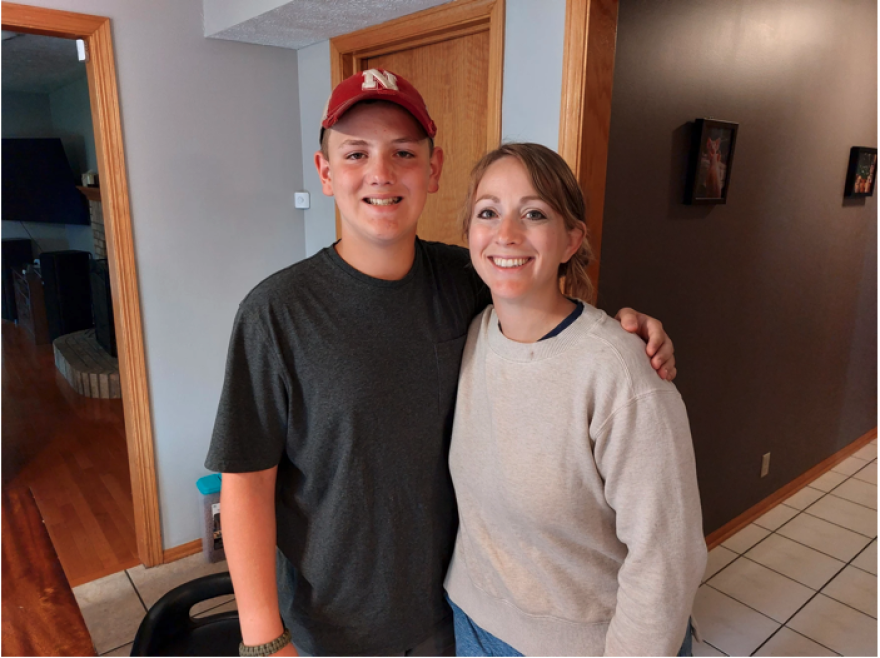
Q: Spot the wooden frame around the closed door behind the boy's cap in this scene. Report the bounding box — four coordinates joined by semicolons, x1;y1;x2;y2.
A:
330;0;504;238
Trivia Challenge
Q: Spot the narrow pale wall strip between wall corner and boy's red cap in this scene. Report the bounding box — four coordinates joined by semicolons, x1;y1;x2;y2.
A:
297;41;336;256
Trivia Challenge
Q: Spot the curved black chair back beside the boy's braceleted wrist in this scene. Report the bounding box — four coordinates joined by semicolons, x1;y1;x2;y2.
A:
131;571;241;656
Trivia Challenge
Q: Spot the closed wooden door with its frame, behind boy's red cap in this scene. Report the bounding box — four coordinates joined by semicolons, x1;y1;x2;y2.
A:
330;0;504;245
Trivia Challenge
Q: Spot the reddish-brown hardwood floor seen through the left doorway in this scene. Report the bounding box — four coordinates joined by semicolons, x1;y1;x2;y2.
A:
2;321;140;587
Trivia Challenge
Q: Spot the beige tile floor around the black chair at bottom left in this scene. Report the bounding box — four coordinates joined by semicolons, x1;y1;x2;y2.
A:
73;554;235;656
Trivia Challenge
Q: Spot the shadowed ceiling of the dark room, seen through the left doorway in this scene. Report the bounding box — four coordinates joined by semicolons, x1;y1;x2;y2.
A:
0;32;86;94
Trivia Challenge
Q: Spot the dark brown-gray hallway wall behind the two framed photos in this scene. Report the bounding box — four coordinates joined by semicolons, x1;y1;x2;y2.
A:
599;0;877;533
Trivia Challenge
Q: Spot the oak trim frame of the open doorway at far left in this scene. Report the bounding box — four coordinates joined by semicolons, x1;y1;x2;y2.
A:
2;2;163;567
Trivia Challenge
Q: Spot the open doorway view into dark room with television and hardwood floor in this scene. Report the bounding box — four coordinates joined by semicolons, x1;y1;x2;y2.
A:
0;31;140;587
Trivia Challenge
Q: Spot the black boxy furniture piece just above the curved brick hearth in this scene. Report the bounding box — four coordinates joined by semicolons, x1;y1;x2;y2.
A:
40;250;93;340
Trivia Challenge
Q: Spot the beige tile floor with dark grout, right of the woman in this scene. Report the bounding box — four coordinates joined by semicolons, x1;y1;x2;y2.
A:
694;440;877;656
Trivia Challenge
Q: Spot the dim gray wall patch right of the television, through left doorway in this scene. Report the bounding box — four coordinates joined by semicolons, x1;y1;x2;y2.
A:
49;76;98;174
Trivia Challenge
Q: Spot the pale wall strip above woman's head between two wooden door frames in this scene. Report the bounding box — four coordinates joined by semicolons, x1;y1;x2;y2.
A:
501;0;565;151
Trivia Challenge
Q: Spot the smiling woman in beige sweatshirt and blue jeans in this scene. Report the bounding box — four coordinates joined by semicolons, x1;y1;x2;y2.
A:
446;144;706;656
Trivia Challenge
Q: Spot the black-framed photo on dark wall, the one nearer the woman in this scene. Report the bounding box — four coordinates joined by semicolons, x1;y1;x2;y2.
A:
684;119;739;204
